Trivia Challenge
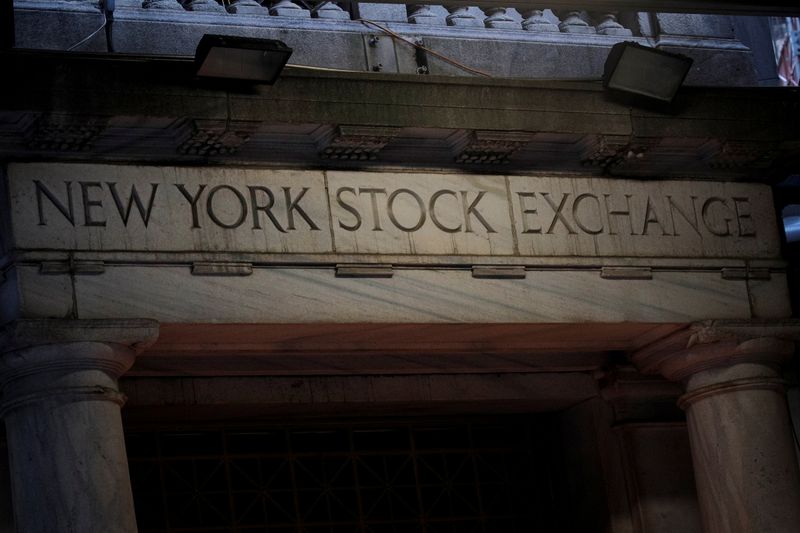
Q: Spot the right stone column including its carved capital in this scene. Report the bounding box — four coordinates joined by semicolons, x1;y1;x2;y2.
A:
633;321;800;533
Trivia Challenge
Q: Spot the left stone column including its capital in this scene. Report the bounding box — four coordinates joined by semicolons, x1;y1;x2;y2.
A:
0;319;158;533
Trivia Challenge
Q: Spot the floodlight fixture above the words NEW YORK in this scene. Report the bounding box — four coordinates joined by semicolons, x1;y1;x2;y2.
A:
194;34;292;85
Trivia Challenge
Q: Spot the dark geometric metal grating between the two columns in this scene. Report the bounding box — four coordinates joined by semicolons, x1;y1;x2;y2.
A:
127;417;558;533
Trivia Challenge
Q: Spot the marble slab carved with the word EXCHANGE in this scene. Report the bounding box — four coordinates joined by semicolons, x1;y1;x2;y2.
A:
509;177;779;257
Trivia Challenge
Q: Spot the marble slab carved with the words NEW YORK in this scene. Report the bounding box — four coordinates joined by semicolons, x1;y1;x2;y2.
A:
10;165;332;252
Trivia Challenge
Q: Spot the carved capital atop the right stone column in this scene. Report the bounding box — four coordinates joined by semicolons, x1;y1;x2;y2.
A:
630;319;800;381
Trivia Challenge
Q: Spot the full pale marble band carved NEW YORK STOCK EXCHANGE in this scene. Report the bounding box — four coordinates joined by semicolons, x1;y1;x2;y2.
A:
8;164;779;257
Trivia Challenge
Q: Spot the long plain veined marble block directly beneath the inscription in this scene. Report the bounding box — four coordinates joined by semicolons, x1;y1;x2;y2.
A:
72;265;750;324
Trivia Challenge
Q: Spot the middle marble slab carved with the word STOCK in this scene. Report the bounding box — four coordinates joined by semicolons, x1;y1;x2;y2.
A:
328;172;514;255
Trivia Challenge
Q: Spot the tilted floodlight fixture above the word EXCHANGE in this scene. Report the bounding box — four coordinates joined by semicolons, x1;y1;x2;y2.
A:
603;41;692;106
